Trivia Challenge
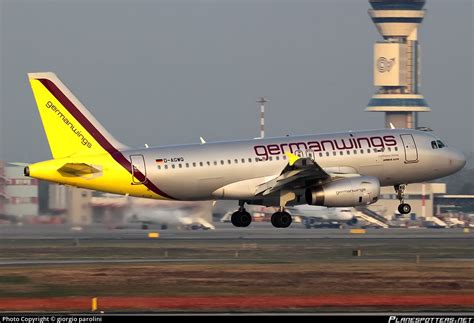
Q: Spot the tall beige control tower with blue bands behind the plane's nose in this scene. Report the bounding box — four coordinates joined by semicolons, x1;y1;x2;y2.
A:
366;0;431;128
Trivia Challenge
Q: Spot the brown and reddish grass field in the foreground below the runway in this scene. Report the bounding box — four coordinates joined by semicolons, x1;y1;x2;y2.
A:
0;239;474;311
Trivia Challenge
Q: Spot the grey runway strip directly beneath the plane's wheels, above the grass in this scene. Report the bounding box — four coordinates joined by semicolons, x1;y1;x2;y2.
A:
0;222;474;241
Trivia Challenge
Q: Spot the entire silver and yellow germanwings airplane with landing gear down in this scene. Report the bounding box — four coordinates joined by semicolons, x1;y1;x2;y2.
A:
24;72;466;228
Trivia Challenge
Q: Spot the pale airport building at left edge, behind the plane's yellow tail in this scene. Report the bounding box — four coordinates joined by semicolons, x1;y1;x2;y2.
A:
0;161;38;219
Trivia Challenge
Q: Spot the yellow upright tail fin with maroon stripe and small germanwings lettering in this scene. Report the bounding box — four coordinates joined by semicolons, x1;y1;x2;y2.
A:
28;73;126;159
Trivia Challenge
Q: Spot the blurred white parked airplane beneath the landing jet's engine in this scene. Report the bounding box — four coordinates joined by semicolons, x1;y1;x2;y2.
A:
287;205;358;228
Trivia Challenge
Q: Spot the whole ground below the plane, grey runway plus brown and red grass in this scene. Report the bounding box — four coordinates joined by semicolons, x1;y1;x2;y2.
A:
0;223;474;312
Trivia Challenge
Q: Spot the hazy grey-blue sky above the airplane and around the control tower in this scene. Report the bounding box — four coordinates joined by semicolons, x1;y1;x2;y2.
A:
0;0;474;162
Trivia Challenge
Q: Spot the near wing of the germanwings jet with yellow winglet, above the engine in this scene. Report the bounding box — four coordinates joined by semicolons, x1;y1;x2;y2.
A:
256;153;359;196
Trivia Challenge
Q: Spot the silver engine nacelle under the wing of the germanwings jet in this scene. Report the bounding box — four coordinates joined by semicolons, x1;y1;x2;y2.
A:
305;176;380;207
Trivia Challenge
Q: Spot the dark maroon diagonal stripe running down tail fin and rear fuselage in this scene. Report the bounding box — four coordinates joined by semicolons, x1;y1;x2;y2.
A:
38;79;176;200
